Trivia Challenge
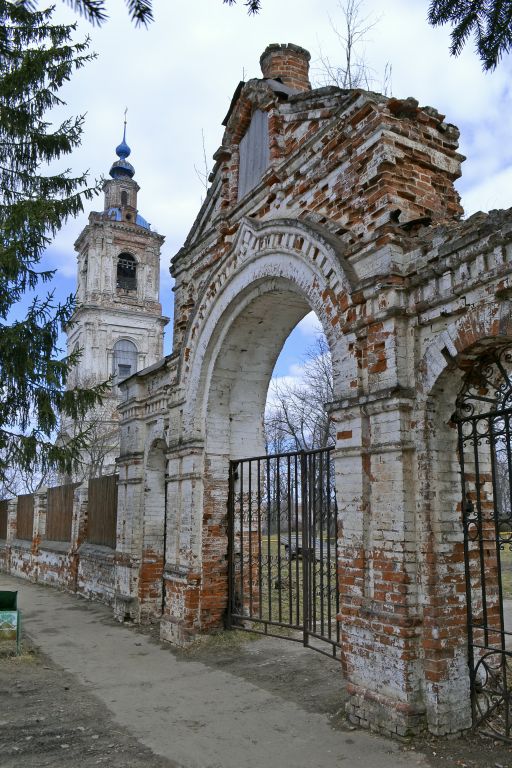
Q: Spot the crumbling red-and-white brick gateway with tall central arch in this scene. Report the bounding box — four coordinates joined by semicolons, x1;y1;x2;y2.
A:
114;45;512;735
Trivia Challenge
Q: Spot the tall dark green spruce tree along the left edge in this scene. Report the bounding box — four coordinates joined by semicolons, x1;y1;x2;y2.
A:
0;0;104;480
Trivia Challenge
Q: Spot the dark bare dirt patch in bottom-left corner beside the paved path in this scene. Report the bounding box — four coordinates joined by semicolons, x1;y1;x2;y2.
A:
0;641;178;768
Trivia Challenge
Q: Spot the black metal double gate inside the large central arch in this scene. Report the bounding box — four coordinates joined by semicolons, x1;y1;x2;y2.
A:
227;448;340;656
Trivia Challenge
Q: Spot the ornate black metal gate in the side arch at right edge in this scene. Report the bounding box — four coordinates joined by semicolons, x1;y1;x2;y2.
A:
455;349;512;740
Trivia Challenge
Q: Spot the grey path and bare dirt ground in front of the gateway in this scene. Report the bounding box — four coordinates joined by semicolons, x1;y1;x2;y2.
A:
0;576;512;768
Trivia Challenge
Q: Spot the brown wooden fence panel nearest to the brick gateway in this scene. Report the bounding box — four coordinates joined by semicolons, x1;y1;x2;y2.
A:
87;475;117;549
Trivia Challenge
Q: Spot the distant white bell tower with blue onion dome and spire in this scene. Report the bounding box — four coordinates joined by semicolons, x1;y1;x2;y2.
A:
60;125;168;477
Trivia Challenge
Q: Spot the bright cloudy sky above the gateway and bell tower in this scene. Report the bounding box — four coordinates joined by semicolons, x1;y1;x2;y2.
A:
43;0;512;371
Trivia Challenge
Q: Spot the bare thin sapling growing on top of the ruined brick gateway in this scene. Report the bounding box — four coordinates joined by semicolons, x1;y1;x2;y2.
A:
318;0;392;95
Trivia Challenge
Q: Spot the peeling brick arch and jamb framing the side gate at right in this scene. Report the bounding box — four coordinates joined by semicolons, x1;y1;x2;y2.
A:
418;314;512;730
